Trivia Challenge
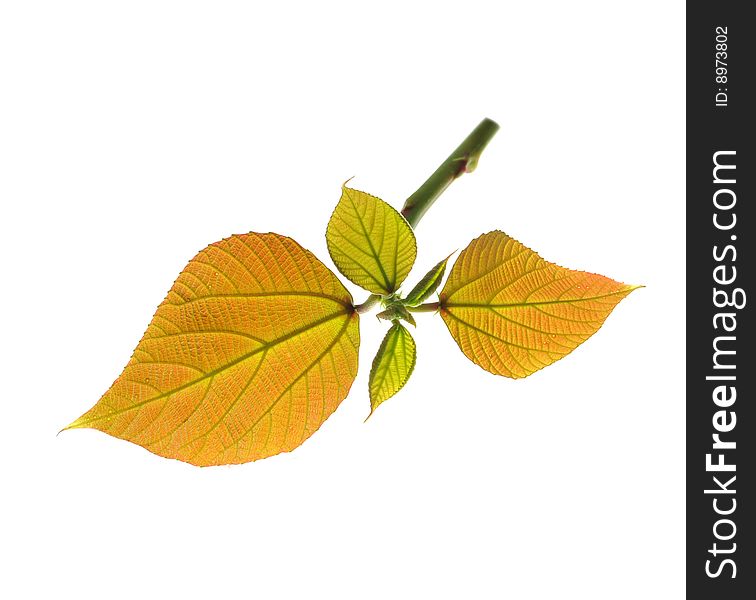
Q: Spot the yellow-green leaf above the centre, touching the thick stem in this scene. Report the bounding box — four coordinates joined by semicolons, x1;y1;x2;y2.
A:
326;186;417;296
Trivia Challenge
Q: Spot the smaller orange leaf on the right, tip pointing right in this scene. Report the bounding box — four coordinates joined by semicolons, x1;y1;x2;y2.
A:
440;231;639;378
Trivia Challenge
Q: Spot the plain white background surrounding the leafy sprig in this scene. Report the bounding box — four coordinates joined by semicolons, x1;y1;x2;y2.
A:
0;0;684;600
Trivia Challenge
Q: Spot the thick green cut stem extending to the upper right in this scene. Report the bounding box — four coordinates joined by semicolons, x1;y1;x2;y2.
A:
402;119;499;227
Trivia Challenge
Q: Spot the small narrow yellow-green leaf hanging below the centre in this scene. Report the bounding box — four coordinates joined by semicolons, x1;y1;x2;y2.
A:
368;321;417;418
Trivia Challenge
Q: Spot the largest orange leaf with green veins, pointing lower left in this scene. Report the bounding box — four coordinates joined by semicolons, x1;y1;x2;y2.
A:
69;233;359;466
